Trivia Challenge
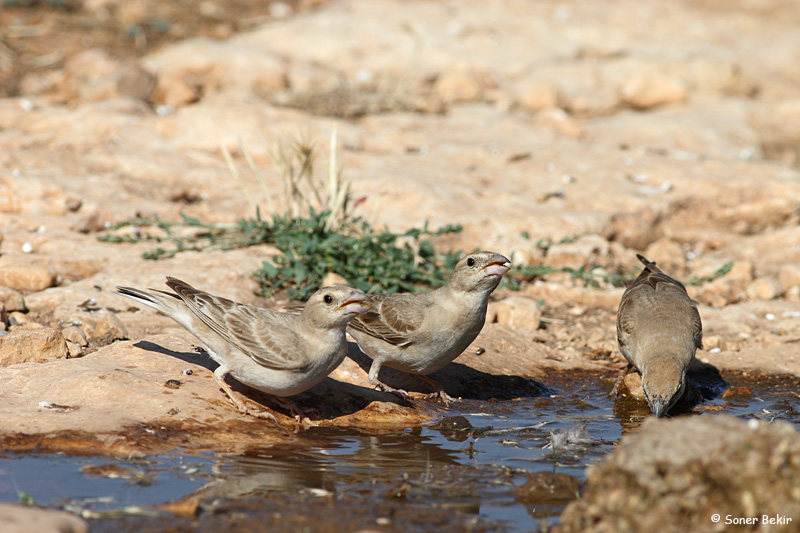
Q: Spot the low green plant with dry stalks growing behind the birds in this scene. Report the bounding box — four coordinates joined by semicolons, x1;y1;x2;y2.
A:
98;130;461;300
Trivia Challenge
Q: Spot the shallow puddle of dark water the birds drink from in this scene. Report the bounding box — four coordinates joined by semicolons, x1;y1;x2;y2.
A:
0;377;800;532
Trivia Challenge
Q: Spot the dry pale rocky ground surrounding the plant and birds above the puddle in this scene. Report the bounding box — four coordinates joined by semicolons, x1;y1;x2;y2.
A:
0;0;800;528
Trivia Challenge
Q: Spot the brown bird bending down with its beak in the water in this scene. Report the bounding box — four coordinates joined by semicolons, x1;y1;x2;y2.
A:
612;254;703;417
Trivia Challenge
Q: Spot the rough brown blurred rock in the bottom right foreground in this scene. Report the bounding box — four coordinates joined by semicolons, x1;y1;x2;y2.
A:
556;415;800;533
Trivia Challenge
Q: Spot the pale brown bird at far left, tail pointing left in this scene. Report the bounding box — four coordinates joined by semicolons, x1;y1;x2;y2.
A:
115;277;367;420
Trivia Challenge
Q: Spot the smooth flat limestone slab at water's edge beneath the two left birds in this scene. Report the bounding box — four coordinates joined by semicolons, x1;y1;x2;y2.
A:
0;324;580;454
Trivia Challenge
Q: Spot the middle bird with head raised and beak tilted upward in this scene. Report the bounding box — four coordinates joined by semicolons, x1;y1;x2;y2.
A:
348;252;510;404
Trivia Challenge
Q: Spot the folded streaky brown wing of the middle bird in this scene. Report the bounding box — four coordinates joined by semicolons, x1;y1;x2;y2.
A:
350;294;429;346
